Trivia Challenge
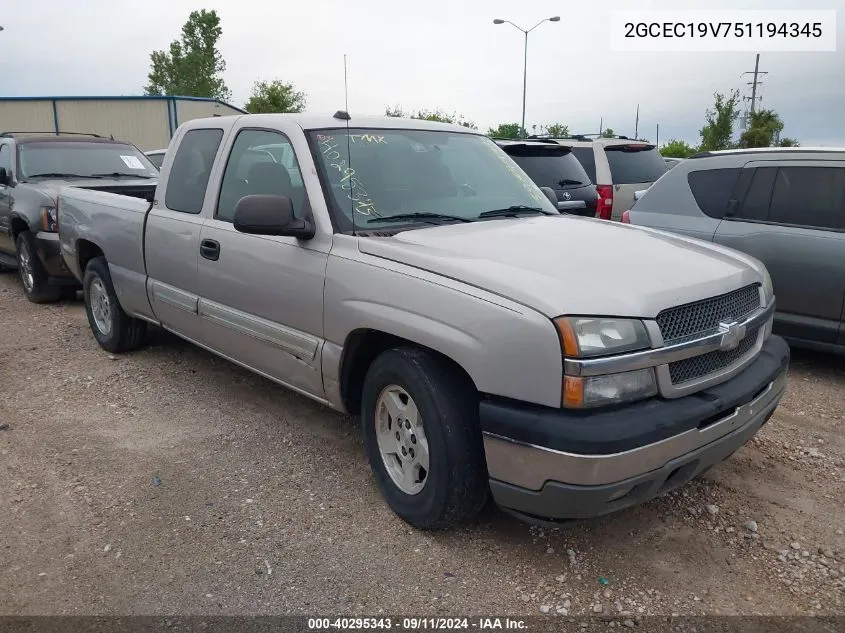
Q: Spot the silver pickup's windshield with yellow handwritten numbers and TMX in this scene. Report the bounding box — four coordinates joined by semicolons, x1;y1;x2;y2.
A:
310;128;558;230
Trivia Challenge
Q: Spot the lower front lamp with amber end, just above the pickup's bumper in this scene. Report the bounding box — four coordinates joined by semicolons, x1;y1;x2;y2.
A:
563;367;657;409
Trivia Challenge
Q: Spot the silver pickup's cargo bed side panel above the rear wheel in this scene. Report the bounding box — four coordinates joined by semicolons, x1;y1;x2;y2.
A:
58;187;152;313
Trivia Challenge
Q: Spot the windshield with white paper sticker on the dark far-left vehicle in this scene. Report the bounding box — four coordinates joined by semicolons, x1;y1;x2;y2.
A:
18;141;158;179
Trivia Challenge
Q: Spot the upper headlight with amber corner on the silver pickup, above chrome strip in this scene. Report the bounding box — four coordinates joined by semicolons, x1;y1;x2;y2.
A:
555;317;651;358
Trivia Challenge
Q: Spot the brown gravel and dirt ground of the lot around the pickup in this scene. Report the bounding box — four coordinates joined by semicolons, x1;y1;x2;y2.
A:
0;273;845;620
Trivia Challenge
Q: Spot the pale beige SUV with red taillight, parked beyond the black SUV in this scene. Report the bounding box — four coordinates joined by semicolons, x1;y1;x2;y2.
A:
552;134;668;221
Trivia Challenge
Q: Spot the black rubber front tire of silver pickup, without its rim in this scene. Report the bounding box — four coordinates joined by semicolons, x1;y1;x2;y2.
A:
361;347;489;530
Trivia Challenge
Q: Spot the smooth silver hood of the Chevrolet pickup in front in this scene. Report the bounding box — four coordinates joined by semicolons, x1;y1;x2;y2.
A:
359;215;765;318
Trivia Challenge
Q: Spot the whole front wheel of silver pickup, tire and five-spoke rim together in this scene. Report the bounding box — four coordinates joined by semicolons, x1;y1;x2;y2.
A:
361;347;489;530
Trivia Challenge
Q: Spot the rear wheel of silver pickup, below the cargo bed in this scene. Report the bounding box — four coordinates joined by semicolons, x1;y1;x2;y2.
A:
82;257;147;352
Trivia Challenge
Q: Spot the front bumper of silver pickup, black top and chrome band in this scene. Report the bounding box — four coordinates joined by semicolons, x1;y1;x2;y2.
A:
480;336;789;520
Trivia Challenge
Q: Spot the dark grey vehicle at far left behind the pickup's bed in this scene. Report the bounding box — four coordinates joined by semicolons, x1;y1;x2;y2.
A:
0;132;158;303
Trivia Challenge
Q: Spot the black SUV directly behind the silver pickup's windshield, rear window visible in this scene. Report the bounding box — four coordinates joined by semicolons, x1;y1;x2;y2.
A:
494;139;599;218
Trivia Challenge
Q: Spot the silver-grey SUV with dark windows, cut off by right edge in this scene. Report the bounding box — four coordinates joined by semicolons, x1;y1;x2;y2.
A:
622;147;845;353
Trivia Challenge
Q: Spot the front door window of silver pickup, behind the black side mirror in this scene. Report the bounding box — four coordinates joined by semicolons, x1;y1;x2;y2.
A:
215;130;304;222
